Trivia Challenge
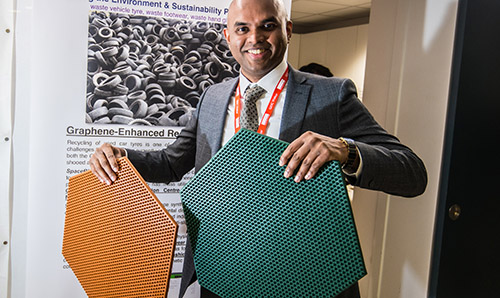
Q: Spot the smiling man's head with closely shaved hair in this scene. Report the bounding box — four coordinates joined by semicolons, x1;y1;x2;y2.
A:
224;0;292;82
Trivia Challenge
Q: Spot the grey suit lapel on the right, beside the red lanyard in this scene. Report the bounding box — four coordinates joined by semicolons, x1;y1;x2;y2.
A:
279;67;311;143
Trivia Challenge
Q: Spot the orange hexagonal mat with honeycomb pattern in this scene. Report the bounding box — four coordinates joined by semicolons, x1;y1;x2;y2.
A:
62;158;177;297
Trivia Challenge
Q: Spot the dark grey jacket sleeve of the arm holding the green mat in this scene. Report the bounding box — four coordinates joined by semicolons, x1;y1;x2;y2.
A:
337;80;427;197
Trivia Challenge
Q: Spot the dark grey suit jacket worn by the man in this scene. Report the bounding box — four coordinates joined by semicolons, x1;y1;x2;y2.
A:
128;67;427;297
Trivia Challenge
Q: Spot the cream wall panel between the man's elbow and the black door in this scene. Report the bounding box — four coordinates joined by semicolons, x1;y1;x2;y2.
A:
362;0;458;298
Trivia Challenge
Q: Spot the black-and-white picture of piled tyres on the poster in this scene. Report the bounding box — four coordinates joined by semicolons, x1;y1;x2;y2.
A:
86;12;239;126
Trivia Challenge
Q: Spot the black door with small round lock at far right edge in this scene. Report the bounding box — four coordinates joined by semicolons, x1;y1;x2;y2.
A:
429;0;500;298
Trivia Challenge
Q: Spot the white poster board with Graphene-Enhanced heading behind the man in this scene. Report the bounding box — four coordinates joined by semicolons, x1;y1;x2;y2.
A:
8;0;291;298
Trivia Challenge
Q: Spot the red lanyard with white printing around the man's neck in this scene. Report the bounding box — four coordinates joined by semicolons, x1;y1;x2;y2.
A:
234;67;288;134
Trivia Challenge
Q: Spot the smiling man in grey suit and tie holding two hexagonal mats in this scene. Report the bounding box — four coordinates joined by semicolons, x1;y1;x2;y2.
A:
90;0;427;297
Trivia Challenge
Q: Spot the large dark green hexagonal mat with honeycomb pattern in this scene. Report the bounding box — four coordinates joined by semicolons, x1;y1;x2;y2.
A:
181;130;366;298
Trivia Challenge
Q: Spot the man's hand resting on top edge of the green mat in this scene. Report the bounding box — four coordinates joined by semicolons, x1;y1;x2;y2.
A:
280;131;348;182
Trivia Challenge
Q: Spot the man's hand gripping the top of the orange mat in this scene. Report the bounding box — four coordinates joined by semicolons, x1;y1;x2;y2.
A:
89;143;125;185
